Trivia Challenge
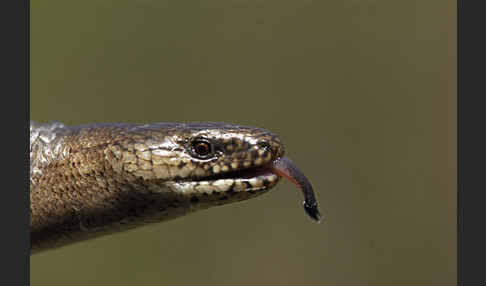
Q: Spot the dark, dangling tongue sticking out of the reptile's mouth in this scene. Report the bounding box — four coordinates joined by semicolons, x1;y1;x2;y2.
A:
271;157;321;223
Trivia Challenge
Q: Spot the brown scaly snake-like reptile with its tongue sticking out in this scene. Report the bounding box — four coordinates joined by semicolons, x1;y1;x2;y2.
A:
30;122;319;253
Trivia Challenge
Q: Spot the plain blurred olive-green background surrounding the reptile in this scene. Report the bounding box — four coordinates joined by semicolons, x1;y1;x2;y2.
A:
30;0;457;286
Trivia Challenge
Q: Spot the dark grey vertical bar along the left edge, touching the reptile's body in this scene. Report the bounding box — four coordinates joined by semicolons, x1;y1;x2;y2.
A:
0;0;30;285
